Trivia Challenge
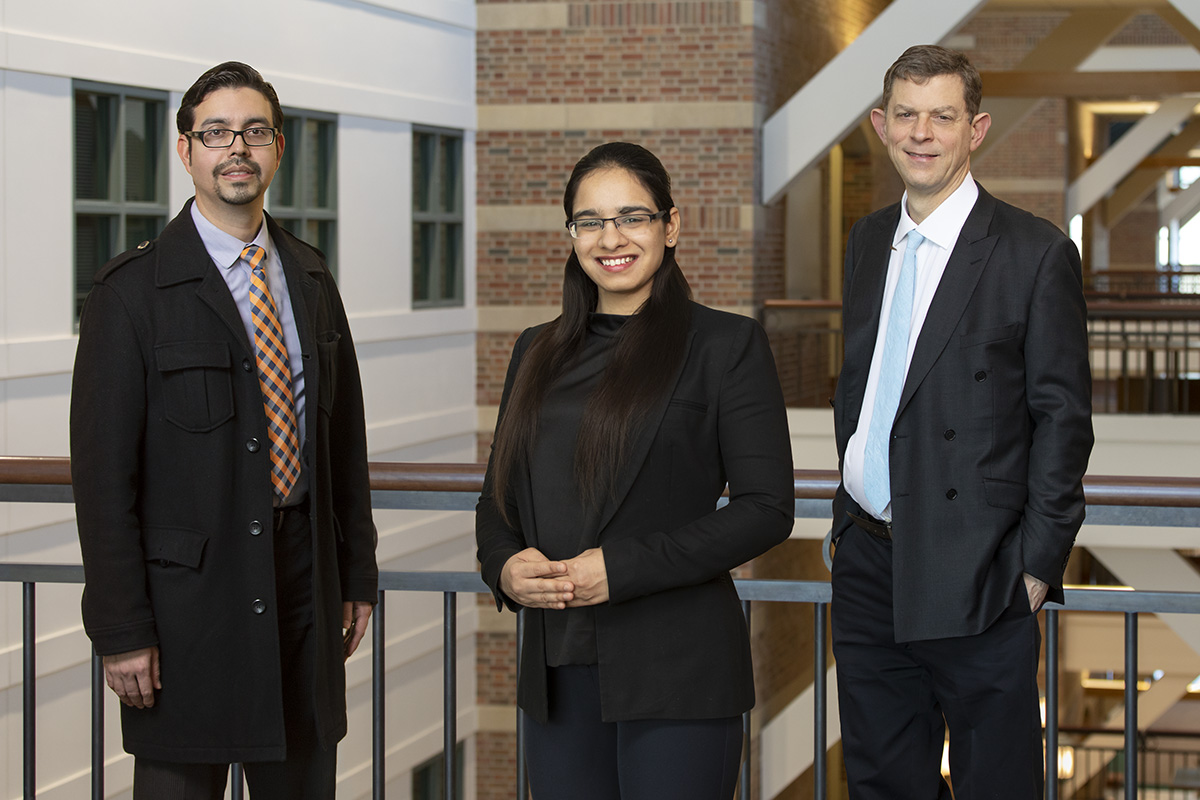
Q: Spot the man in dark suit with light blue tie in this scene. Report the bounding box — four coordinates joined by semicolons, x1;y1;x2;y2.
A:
833;46;1092;800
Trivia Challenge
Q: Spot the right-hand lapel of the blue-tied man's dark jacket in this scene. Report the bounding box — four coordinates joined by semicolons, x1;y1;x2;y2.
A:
896;186;997;416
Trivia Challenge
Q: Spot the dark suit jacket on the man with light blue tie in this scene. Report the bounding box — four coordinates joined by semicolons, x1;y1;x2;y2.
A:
833;188;1092;640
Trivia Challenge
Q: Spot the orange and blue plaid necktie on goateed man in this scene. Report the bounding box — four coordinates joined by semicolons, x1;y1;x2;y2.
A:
241;245;300;500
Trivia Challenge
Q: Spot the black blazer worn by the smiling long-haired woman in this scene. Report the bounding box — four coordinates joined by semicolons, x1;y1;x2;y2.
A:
475;305;794;721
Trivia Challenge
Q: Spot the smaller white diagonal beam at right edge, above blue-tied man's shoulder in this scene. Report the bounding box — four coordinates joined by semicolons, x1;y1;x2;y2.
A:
1067;97;1198;219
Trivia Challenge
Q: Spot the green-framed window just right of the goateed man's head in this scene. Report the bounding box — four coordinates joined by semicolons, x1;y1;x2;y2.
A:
268;110;337;275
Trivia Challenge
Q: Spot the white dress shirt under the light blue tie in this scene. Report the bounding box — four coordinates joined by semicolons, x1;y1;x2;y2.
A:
841;173;979;521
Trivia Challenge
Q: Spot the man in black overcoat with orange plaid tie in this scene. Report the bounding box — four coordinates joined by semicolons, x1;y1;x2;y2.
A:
71;61;378;800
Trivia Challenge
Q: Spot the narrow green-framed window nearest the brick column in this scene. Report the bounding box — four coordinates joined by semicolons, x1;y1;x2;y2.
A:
413;130;463;307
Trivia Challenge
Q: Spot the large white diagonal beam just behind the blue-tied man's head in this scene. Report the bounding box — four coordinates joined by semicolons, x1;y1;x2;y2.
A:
762;0;985;204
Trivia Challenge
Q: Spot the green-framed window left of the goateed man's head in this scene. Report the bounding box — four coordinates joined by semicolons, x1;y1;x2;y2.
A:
73;80;169;320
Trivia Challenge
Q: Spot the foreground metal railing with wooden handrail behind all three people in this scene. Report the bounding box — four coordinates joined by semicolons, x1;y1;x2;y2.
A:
0;456;1200;800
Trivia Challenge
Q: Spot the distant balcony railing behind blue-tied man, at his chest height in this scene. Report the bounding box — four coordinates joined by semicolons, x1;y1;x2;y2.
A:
762;298;1200;414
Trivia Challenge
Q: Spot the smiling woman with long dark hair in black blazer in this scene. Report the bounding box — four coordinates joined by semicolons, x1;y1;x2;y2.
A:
475;143;793;800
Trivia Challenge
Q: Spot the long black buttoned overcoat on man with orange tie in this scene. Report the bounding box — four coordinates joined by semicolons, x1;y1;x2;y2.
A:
71;203;378;763
